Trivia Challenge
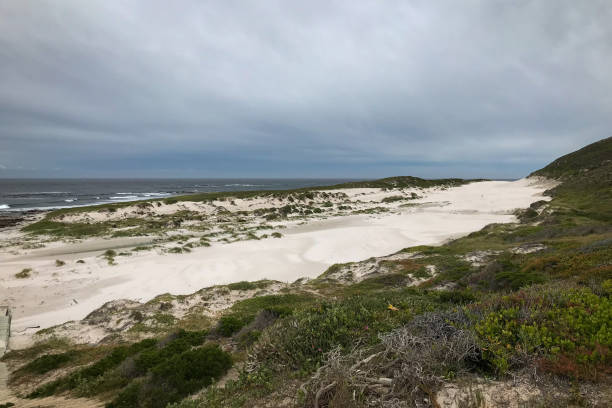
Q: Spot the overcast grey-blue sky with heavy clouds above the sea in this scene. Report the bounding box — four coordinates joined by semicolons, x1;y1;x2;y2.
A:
0;0;612;178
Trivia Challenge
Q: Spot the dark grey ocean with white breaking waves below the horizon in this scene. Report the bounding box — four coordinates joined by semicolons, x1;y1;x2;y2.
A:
0;178;352;212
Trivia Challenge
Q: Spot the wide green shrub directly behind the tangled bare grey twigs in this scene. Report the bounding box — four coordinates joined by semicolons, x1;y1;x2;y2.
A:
252;289;437;372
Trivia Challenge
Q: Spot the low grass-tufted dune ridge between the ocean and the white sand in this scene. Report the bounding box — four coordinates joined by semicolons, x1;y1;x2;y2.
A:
17;177;468;239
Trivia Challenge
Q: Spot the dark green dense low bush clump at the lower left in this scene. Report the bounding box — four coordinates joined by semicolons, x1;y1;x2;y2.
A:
28;330;221;407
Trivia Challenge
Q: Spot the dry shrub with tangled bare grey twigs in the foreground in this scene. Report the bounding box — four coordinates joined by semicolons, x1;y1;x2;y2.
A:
302;311;480;408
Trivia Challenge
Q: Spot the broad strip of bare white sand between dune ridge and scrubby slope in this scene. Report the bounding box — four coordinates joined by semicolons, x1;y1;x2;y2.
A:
0;180;549;344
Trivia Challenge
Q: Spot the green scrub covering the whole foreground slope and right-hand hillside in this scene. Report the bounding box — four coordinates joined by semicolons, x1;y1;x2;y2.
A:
4;138;612;408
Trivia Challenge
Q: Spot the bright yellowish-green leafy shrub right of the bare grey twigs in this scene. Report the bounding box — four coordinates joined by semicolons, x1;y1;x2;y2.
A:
470;286;612;378
